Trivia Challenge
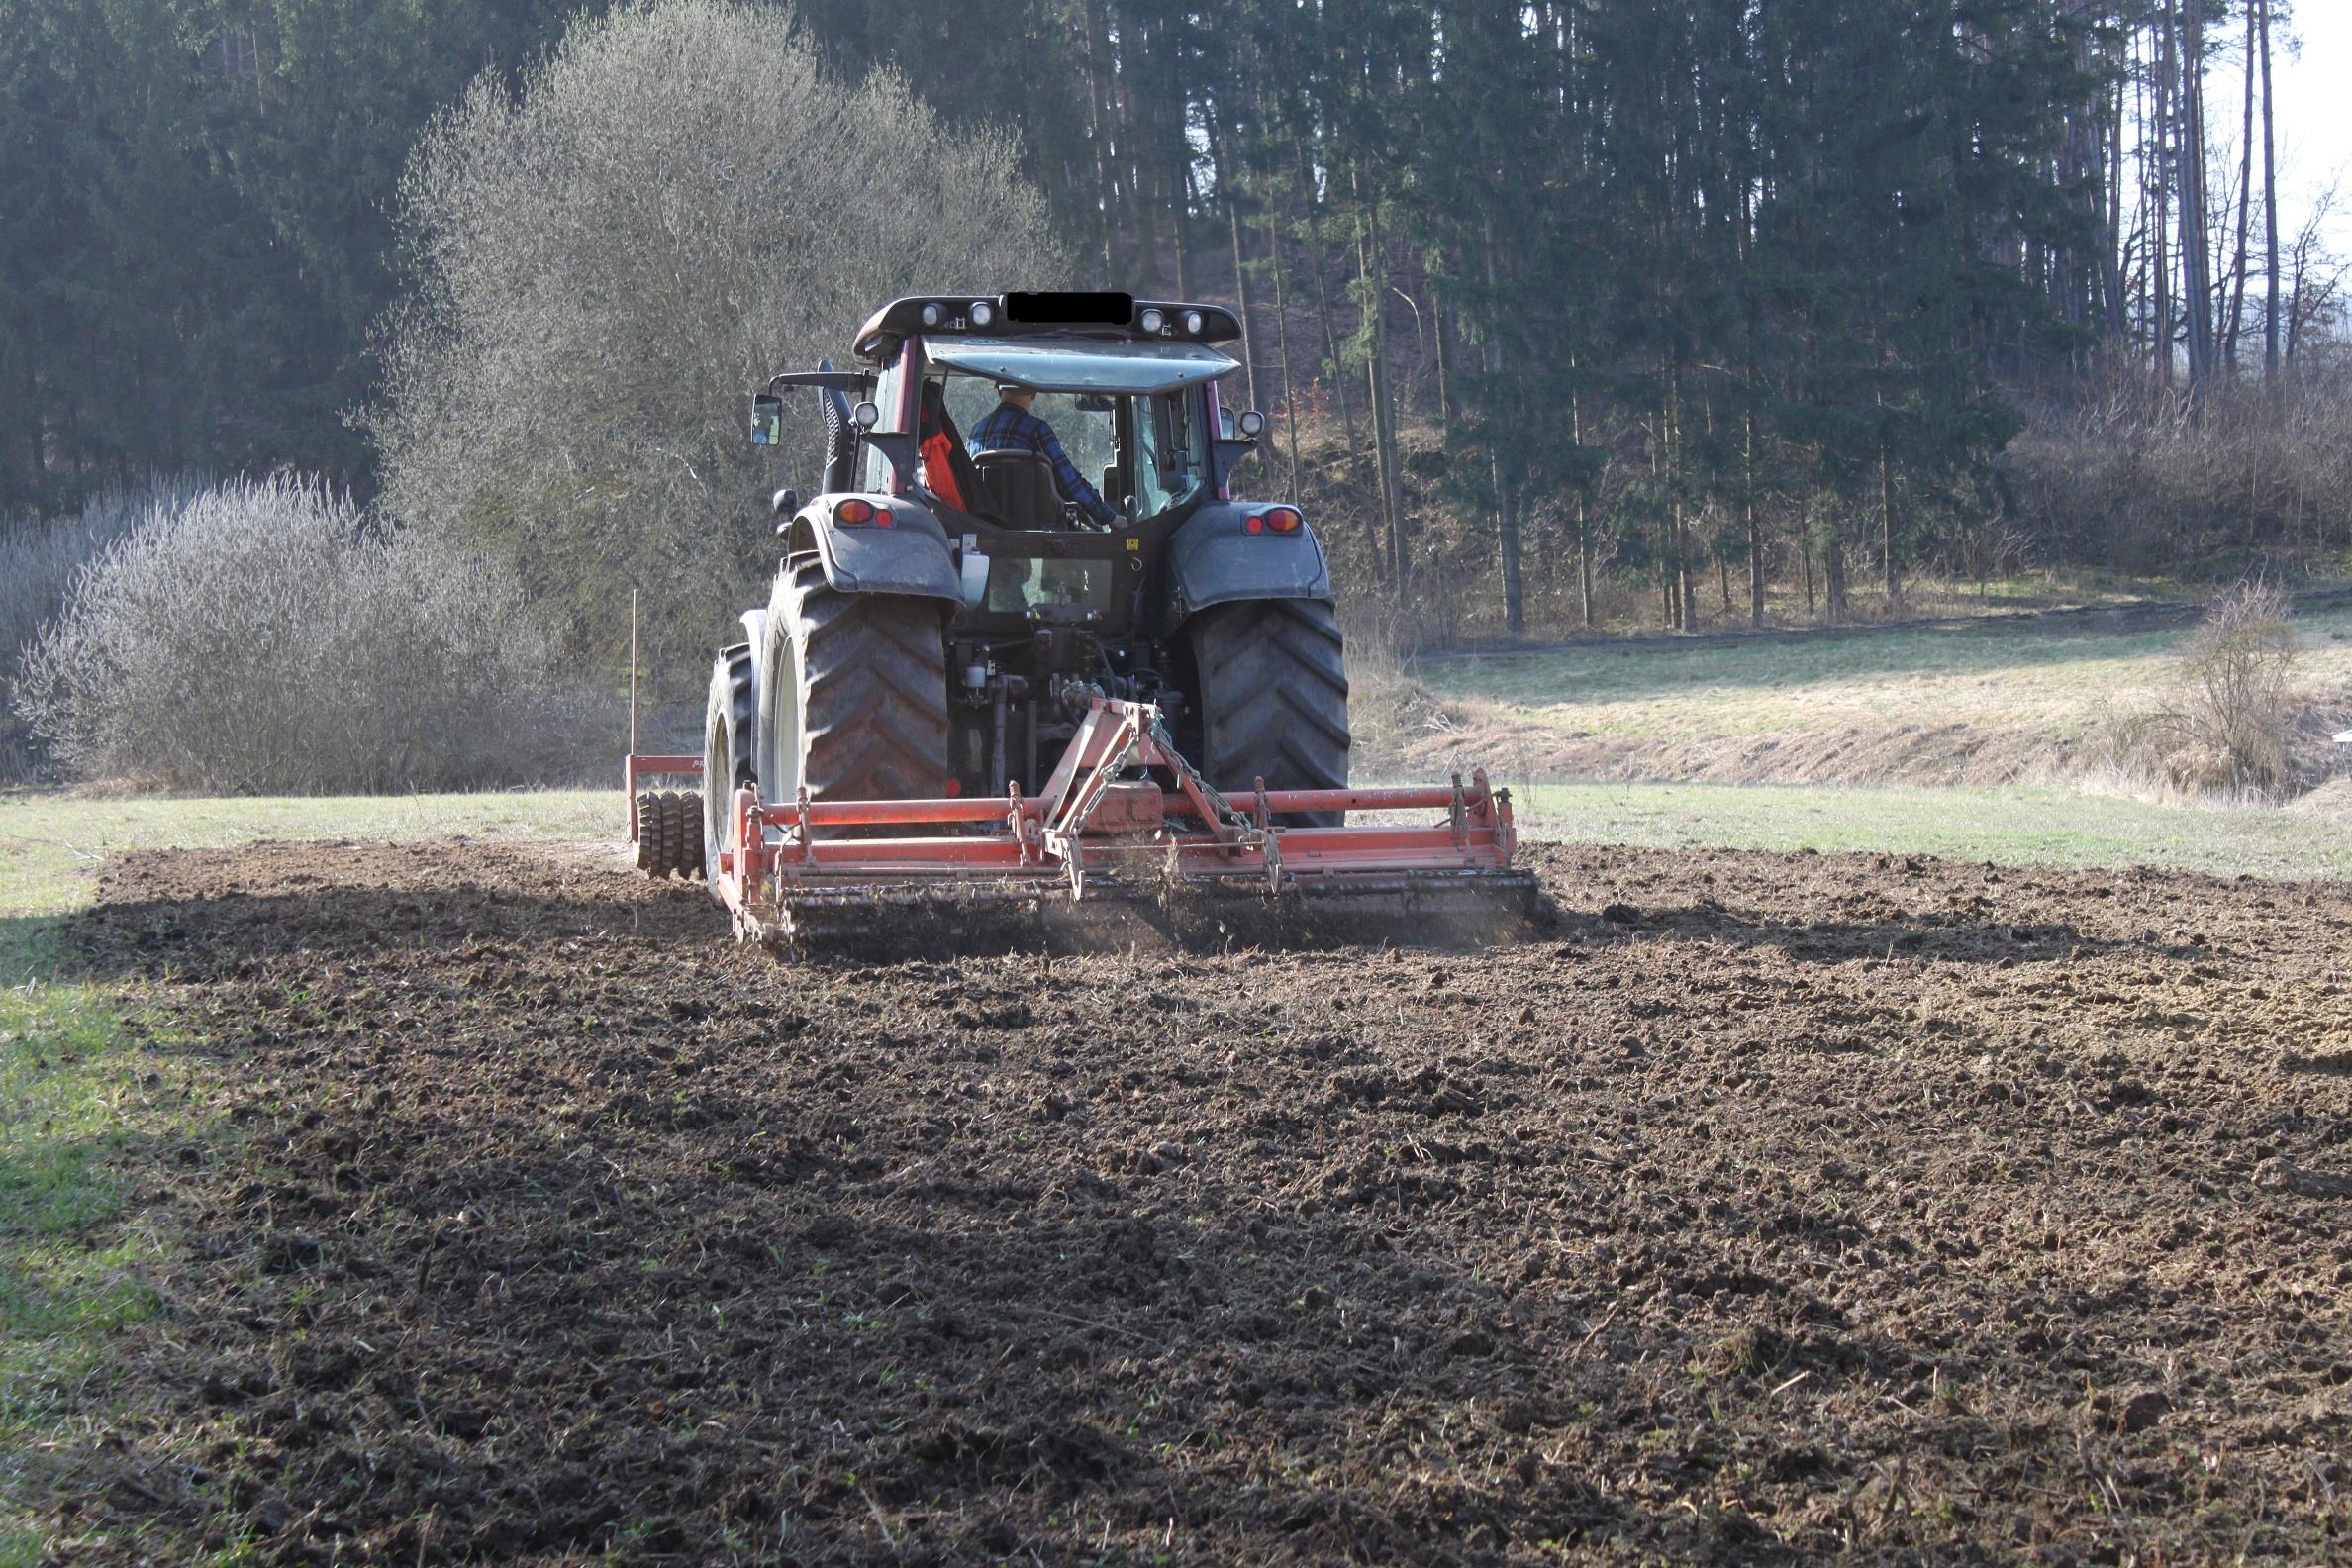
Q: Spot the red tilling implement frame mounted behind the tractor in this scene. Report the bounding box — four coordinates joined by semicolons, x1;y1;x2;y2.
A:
631;698;1536;942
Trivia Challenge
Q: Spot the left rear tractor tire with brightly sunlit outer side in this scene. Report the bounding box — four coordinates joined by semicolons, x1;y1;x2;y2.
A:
757;554;955;807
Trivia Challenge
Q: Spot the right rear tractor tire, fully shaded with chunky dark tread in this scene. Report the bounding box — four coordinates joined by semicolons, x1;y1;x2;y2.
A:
1186;600;1350;828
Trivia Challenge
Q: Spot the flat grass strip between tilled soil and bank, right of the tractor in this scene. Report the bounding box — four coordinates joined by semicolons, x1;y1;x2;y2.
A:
1513;783;2352;882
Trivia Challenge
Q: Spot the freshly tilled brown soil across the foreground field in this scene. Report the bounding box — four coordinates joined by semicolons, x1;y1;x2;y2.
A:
58;846;2352;1563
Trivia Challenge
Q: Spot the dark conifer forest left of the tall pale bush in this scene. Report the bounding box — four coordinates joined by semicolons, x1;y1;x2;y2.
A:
0;0;597;508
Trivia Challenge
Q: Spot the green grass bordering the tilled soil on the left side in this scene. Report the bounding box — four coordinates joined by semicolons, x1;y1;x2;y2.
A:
0;790;602;1568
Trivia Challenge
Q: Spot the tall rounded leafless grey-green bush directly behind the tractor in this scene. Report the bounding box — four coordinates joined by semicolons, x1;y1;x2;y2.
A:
367;0;1065;691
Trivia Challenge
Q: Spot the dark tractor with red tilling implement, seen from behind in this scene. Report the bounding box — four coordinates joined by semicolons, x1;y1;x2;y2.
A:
628;294;1533;940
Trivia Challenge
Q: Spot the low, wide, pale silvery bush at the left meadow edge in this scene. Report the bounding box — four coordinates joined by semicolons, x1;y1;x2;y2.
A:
14;477;562;792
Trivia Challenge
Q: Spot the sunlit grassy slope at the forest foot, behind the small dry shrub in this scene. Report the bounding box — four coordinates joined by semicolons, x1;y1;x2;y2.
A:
1416;611;2352;742
